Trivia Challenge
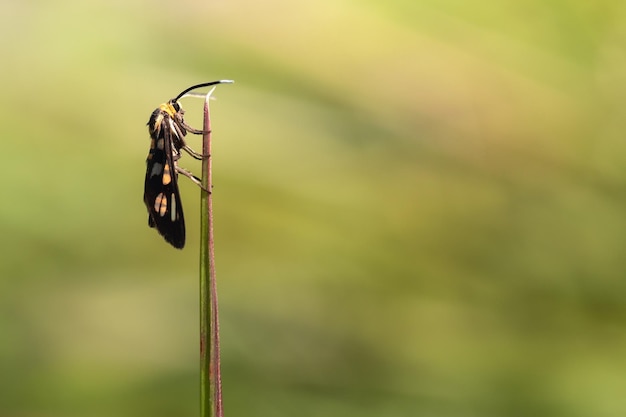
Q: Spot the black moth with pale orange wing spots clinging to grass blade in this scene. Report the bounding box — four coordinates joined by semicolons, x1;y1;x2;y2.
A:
143;80;225;249
